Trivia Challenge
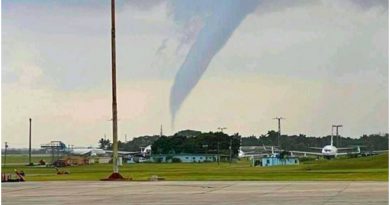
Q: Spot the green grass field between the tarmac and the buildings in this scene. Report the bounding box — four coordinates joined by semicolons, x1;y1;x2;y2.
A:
2;154;388;181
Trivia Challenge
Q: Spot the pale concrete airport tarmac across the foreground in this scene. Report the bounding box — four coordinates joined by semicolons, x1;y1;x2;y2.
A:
2;181;389;205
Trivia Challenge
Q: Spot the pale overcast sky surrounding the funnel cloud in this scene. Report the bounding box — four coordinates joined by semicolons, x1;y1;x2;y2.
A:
1;0;389;147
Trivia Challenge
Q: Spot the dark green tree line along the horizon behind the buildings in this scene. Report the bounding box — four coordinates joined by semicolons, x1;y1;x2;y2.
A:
99;130;389;156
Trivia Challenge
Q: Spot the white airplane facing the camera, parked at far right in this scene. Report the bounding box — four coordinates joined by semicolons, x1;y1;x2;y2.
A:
289;135;360;159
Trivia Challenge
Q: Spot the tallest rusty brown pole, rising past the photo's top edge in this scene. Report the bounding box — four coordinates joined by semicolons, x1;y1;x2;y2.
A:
111;0;119;173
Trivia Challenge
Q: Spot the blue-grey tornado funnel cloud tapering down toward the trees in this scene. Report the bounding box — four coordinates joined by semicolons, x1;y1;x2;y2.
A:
170;0;258;126
